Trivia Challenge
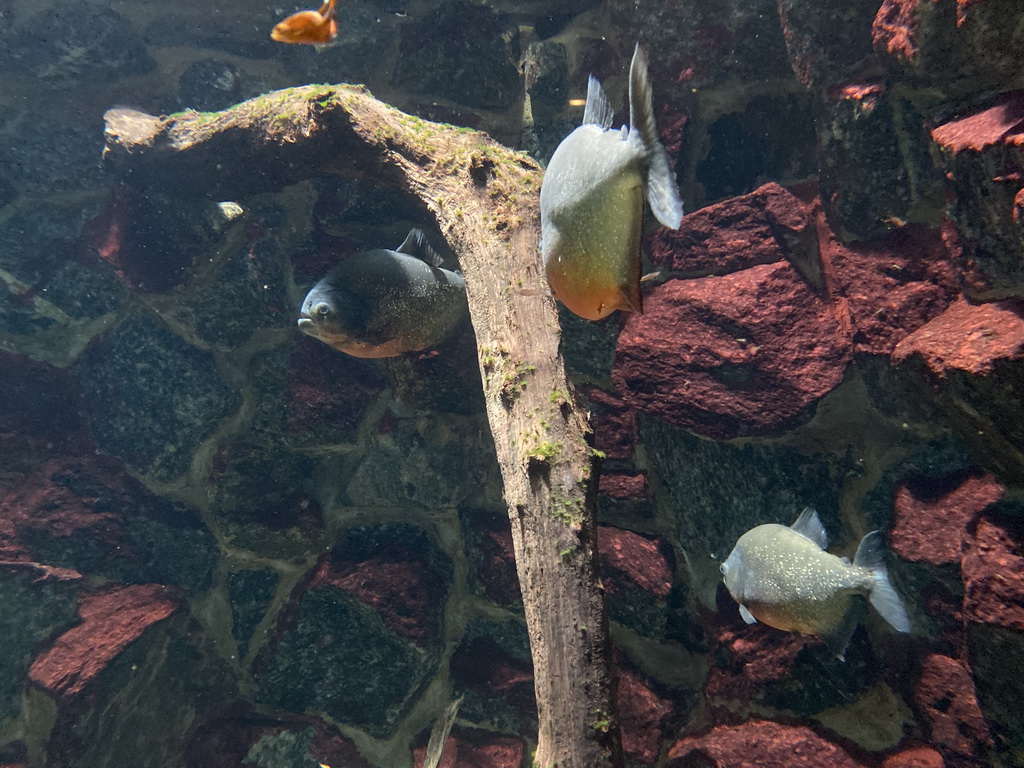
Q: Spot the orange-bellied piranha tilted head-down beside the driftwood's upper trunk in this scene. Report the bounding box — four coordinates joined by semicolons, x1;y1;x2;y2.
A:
541;45;683;321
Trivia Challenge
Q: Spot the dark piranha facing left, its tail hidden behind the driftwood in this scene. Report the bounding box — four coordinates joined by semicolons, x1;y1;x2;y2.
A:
299;229;469;357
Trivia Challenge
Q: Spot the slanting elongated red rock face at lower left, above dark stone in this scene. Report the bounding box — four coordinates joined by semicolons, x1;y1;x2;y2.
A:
29;584;180;698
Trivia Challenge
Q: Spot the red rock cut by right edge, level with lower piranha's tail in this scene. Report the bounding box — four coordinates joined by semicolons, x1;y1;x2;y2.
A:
961;517;1024;632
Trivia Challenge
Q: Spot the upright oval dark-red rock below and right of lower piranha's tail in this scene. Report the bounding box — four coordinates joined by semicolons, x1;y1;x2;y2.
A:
914;653;989;757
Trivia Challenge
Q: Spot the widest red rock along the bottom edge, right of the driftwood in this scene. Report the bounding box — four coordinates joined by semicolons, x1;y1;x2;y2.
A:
666;720;866;768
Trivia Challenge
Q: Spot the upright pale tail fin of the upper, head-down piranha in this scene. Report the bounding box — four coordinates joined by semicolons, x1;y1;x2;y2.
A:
626;43;683;229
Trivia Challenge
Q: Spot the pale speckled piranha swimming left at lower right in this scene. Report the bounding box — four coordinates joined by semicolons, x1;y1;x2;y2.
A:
721;507;910;659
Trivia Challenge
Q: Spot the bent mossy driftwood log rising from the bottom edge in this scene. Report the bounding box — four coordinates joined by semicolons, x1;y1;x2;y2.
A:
104;85;622;768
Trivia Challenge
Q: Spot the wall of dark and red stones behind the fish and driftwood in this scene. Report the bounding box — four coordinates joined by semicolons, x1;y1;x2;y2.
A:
0;0;1024;768
